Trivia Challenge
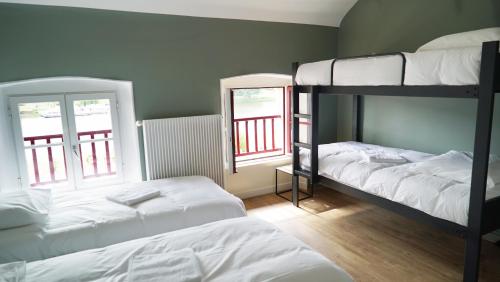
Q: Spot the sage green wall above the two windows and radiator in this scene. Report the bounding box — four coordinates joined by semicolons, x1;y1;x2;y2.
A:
0;4;337;176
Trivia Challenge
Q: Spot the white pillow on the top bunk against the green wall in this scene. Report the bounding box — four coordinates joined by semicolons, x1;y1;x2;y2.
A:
417;27;500;52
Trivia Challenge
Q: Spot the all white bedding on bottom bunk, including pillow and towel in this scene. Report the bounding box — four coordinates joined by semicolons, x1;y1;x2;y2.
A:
300;142;500;226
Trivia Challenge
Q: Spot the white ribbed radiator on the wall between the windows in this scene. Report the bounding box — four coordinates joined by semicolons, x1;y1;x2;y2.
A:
142;115;224;187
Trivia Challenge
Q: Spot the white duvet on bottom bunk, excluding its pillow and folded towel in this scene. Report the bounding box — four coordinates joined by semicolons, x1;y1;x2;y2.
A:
300;142;500;226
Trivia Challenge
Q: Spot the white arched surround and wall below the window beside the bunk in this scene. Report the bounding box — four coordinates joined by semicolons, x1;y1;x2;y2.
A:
220;74;292;198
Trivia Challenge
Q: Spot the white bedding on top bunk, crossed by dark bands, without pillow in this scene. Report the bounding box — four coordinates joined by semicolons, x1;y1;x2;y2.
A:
295;47;481;86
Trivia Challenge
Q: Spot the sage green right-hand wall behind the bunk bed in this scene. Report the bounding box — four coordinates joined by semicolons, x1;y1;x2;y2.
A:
338;0;500;153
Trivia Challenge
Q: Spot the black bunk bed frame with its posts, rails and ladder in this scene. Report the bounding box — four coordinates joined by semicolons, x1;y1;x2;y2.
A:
292;41;500;282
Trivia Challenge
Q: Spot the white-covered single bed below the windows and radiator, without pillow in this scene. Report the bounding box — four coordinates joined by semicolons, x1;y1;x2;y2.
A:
0;176;246;264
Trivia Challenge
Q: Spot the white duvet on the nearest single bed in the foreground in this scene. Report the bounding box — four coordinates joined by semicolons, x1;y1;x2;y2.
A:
20;217;352;282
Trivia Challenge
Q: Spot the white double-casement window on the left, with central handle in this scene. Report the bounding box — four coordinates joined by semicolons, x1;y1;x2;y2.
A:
9;93;122;188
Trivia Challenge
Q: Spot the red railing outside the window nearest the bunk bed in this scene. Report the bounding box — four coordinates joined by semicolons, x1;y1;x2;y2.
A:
233;115;282;157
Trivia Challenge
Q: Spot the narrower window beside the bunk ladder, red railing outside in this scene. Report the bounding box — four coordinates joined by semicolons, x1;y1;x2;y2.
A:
231;87;291;162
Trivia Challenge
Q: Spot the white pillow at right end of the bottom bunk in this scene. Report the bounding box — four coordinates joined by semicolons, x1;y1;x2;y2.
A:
412;151;500;189
